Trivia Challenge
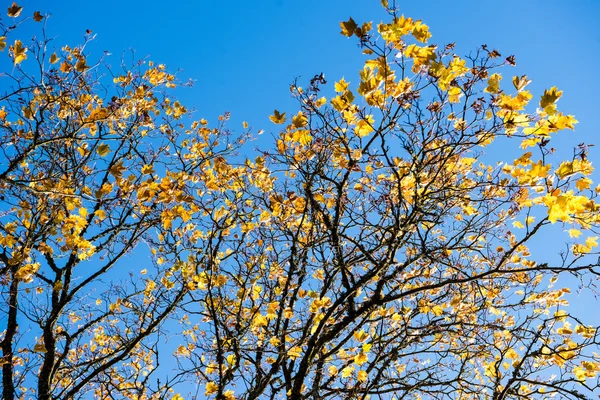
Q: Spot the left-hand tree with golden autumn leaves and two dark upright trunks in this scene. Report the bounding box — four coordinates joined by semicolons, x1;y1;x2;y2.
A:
0;4;244;399
